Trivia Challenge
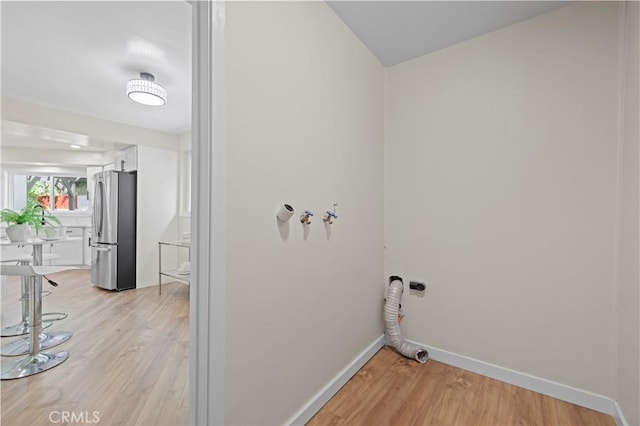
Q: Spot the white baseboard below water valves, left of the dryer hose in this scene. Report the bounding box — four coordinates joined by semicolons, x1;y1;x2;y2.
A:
285;335;384;425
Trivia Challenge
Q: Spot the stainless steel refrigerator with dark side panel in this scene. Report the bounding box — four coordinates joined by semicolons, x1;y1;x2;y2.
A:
90;170;137;290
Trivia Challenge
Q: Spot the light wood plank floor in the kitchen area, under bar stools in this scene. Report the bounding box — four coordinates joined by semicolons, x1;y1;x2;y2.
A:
0;270;189;425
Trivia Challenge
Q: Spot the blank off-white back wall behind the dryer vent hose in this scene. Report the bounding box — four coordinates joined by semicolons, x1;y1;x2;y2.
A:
385;3;618;396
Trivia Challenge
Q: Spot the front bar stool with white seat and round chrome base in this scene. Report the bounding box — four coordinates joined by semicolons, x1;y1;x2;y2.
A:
0;265;78;380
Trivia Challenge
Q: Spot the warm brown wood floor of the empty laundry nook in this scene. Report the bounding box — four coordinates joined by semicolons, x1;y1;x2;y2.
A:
307;347;615;426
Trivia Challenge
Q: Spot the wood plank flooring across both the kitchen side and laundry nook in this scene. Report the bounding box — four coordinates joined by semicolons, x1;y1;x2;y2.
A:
0;271;615;426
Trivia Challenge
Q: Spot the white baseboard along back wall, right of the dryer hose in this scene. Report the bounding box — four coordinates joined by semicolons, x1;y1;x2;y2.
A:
414;342;626;426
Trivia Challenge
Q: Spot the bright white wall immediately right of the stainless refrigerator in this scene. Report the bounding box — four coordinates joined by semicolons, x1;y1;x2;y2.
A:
136;146;178;288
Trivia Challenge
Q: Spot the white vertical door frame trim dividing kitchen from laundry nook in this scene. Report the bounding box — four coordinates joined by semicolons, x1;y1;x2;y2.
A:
0;2;224;424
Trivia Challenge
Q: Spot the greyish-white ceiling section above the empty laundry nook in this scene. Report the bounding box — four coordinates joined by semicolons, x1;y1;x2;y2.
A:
328;1;571;66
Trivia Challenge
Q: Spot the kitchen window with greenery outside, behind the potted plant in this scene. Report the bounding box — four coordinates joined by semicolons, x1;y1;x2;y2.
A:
13;175;89;211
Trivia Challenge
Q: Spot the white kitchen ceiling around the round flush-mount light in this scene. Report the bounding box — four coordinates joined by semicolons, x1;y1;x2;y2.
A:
0;0;191;134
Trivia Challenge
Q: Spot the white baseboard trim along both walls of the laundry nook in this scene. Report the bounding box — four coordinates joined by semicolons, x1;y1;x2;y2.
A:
286;335;628;426
